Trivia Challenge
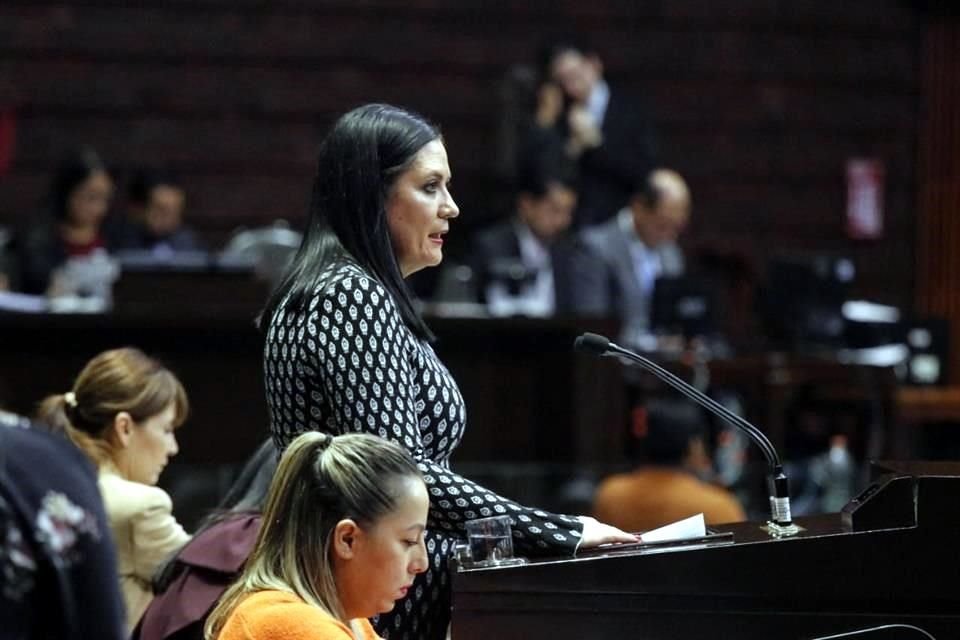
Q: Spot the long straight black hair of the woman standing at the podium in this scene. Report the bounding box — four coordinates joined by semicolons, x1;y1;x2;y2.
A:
260;104;440;340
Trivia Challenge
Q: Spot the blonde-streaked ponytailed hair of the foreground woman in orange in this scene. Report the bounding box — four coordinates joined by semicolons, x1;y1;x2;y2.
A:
204;431;422;640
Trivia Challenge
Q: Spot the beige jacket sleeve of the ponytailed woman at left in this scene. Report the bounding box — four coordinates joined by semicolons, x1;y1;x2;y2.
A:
131;487;190;582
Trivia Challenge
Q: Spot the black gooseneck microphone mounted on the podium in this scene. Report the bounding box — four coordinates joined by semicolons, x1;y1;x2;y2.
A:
573;333;799;536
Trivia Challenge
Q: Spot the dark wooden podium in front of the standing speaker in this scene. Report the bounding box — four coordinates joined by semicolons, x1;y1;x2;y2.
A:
452;462;960;640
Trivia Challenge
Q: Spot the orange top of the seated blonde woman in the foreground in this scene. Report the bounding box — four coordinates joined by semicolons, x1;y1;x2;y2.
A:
217;591;379;640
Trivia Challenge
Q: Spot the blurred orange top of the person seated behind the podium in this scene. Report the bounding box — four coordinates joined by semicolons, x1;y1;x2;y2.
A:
593;468;746;532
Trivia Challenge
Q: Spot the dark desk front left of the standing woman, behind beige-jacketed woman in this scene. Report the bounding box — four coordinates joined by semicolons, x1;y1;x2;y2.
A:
0;311;267;464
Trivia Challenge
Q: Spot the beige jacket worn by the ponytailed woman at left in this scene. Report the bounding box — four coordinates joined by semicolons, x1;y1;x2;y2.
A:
99;464;190;633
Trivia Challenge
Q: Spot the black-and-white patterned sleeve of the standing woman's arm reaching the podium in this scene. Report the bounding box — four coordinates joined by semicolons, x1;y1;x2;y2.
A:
304;278;583;555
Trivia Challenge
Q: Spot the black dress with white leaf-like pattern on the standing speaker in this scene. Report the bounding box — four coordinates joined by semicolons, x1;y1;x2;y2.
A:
264;263;583;640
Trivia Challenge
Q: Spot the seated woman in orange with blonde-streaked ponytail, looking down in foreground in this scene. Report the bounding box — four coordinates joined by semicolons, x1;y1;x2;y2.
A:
205;432;429;640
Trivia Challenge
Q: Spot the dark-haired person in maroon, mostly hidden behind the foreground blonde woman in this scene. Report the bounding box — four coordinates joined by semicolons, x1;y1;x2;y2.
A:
131;440;277;640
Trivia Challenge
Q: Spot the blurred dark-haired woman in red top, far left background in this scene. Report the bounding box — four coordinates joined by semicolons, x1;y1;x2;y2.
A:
14;147;115;295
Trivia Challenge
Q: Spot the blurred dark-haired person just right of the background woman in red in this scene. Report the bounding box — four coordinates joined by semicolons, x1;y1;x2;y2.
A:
119;168;203;256
